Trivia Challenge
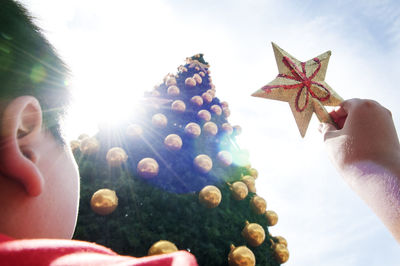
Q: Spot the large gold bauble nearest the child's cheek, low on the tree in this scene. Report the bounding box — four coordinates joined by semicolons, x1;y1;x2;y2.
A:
90;188;118;215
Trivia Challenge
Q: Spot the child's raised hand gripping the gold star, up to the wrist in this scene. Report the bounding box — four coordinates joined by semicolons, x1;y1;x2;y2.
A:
320;99;400;171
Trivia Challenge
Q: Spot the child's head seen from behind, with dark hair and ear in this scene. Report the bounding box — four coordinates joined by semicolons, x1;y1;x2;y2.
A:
0;0;79;238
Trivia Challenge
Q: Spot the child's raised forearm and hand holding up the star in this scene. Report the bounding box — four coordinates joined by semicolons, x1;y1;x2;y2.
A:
320;99;400;243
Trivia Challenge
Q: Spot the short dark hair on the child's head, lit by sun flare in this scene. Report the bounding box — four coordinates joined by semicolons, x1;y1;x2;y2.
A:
0;0;70;143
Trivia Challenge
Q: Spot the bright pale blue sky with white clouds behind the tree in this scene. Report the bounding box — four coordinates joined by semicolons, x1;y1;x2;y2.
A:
21;0;400;266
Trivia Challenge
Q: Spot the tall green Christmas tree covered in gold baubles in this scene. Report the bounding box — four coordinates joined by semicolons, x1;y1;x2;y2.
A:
71;54;289;266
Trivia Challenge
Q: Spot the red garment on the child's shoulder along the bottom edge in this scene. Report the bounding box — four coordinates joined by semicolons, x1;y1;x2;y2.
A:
0;234;197;266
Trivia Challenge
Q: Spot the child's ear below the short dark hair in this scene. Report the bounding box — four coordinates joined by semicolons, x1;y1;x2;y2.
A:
0;96;44;197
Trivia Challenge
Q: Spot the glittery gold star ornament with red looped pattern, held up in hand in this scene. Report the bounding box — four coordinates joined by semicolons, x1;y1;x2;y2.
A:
252;43;343;137
